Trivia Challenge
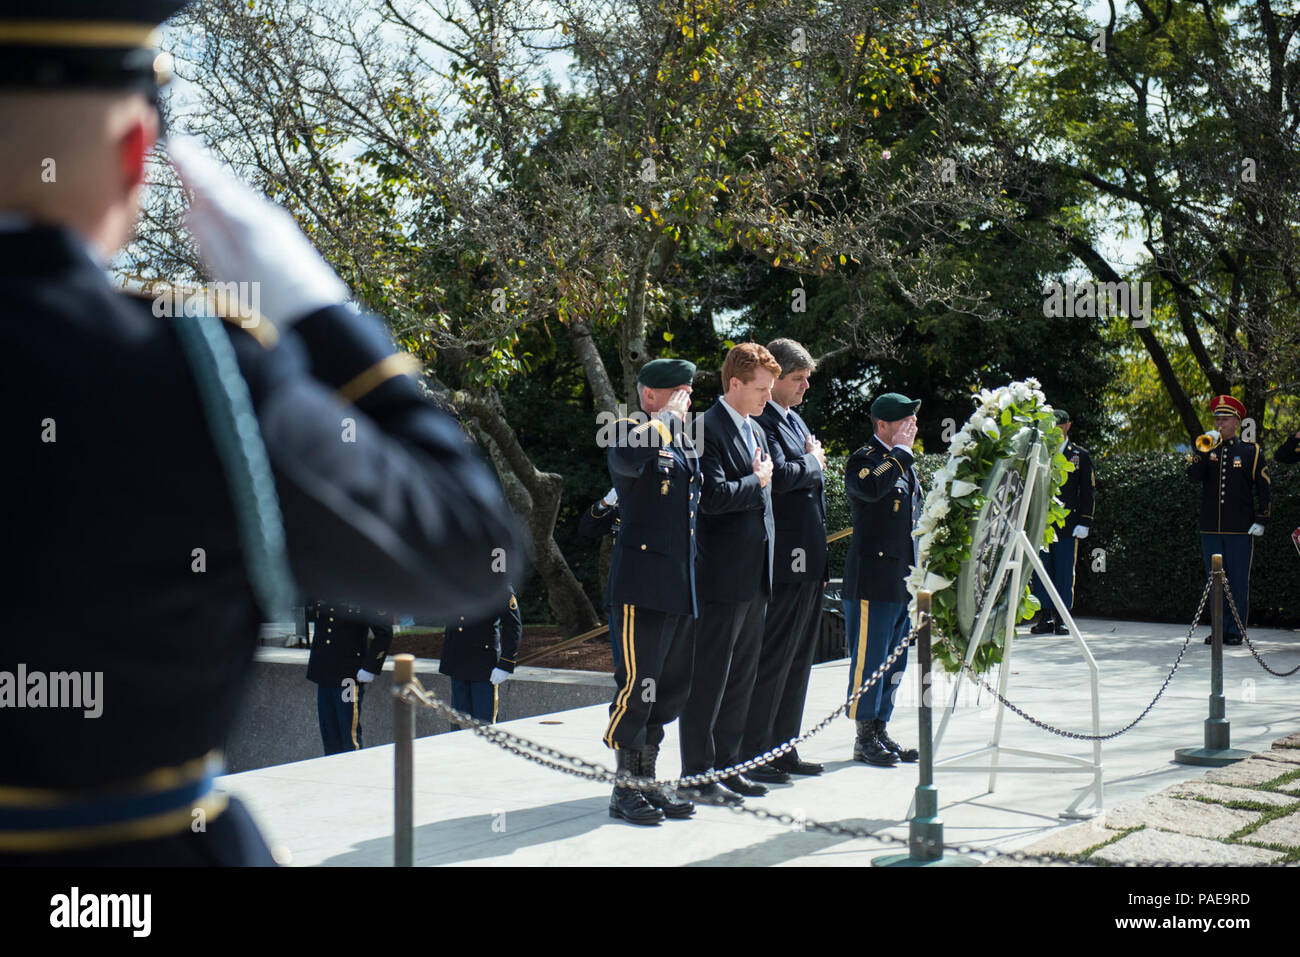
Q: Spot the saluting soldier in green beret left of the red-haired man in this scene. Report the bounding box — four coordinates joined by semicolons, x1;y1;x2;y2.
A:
602;359;701;824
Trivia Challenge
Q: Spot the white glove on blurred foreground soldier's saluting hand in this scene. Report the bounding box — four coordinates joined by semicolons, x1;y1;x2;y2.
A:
166;137;347;325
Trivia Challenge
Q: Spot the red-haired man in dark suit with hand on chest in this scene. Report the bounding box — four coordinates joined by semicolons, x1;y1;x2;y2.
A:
681;342;781;802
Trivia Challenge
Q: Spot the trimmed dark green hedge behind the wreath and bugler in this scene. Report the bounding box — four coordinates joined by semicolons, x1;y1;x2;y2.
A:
827;452;1300;627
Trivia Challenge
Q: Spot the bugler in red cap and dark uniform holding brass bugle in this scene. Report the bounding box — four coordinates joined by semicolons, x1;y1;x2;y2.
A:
1187;395;1271;645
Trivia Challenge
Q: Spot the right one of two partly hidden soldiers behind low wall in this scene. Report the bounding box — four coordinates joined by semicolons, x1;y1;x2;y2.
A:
438;592;524;723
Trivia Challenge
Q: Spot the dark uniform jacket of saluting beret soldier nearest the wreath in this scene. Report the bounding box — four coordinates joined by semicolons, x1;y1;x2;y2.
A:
844;436;920;602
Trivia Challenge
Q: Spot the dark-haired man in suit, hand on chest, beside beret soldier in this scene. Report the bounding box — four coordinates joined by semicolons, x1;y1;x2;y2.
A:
741;339;827;784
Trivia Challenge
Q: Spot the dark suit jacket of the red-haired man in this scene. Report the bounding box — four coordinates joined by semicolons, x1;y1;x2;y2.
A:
696;399;776;602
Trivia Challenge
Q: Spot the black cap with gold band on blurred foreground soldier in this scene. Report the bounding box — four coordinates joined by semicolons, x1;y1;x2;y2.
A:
0;0;189;96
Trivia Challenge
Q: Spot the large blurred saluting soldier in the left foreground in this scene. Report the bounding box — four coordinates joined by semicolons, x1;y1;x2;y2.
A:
0;3;524;866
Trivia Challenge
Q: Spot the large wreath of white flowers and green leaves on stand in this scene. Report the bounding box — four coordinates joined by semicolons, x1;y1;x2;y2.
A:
907;378;1074;672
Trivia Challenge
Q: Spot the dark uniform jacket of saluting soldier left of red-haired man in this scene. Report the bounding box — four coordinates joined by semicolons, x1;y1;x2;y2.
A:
608;416;701;618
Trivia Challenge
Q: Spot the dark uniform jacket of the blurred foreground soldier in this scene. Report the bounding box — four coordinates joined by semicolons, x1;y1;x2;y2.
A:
0;228;524;787
